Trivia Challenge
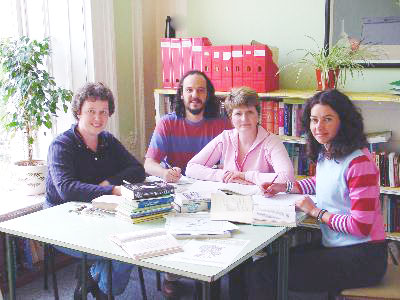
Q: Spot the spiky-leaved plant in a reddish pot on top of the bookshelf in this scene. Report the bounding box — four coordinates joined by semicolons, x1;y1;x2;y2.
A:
279;36;378;90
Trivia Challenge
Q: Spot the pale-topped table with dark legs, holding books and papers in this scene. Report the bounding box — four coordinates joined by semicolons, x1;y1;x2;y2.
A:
0;202;288;299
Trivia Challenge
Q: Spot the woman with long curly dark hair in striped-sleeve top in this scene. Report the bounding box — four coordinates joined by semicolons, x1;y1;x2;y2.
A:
248;90;387;299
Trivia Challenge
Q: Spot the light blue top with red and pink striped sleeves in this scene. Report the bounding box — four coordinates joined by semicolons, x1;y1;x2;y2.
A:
298;149;385;247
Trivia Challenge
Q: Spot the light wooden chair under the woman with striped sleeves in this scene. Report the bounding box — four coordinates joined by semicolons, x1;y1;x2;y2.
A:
340;264;400;300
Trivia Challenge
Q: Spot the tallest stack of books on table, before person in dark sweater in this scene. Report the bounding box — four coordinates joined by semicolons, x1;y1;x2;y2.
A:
116;181;175;223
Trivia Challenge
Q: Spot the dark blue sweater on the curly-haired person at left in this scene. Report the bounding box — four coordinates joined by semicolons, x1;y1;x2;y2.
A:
46;125;145;206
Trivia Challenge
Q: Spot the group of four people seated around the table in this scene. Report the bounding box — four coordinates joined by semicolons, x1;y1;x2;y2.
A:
46;71;387;299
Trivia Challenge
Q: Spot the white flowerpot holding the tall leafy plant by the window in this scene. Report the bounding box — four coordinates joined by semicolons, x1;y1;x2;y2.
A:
13;160;47;195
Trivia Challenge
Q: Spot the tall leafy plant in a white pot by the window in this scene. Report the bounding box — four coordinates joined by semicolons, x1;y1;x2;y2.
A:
0;37;72;194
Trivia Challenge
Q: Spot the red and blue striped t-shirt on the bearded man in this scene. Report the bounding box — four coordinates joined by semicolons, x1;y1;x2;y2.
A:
146;113;232;174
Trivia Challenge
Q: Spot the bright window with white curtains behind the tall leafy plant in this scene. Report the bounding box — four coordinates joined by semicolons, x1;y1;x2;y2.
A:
0;0;118;188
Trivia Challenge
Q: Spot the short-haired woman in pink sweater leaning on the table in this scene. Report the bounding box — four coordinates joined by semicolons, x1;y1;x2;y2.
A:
186;87;294;185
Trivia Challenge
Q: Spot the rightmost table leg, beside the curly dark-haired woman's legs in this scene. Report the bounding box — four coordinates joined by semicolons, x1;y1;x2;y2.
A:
277;234;289;300
